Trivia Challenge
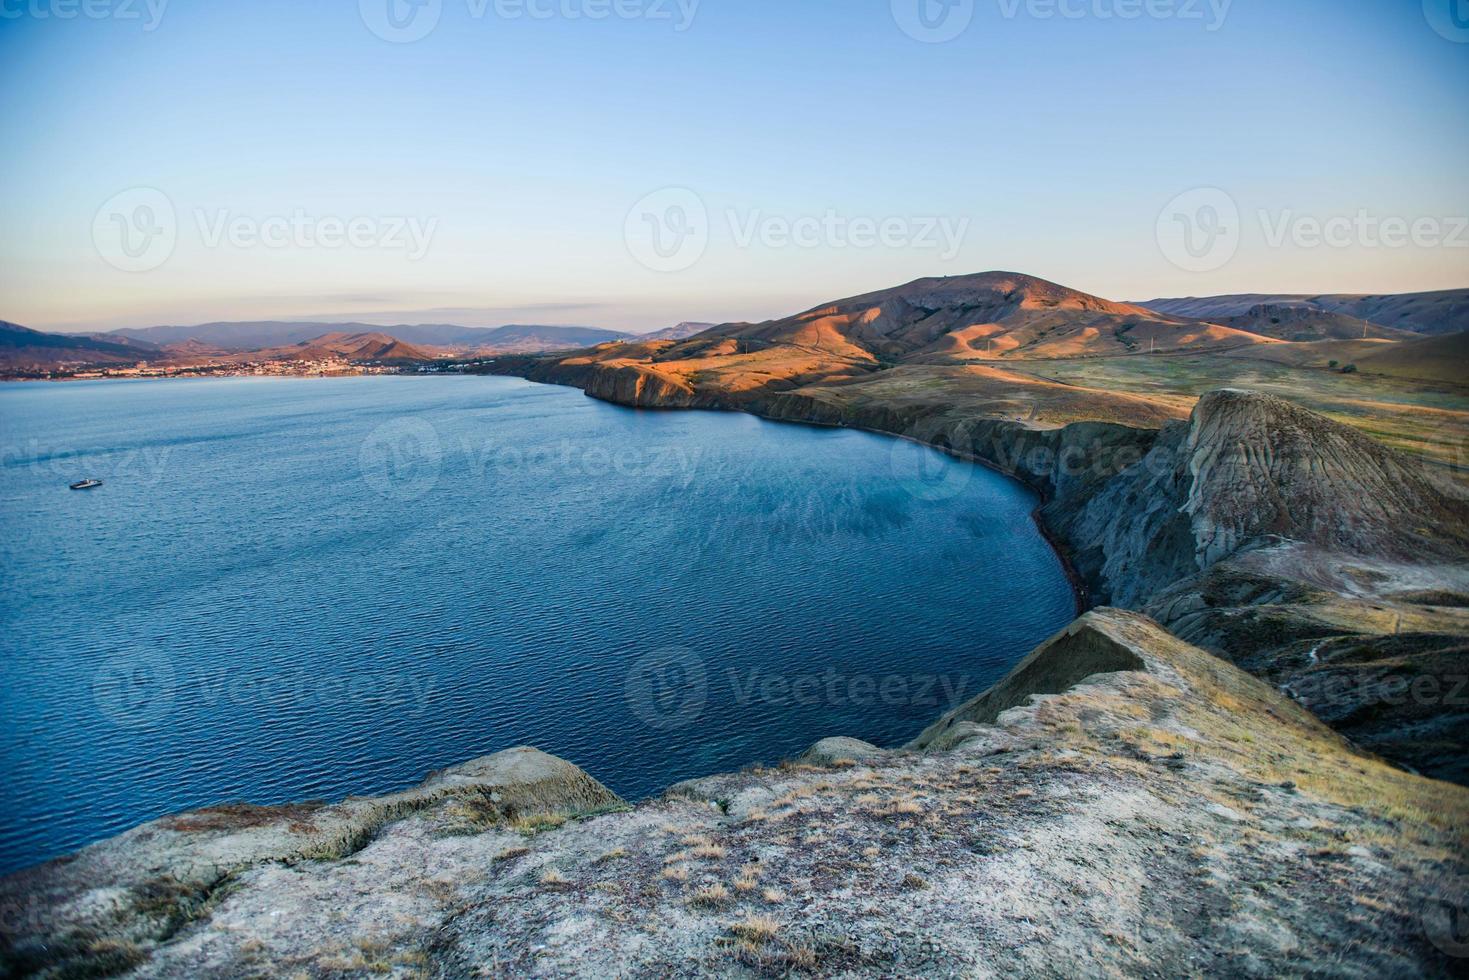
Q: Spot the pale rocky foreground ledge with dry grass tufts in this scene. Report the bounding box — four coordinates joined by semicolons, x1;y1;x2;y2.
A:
0;610;1469;977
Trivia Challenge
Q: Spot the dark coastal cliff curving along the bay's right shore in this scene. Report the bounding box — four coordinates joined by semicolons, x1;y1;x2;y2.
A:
491;348;1469;782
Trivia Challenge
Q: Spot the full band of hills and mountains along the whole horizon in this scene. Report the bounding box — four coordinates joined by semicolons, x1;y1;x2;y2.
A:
0;287;1469;373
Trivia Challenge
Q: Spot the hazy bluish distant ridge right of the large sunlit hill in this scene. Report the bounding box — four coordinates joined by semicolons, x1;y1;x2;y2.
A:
1138;289;1469;334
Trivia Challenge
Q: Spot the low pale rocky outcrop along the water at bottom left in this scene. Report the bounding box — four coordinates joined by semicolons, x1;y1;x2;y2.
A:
0;748;624;976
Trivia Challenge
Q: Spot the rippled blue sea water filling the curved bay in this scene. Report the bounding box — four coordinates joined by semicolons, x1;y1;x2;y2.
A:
0;376;1074;871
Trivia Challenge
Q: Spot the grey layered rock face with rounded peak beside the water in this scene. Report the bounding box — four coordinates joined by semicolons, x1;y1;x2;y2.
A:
1058;389;1469;605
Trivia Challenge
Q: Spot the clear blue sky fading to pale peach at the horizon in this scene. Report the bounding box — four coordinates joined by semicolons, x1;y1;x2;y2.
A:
0;0;1469;331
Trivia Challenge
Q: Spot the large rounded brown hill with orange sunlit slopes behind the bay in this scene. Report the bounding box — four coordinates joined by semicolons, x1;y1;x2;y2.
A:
715;272;1271;364
